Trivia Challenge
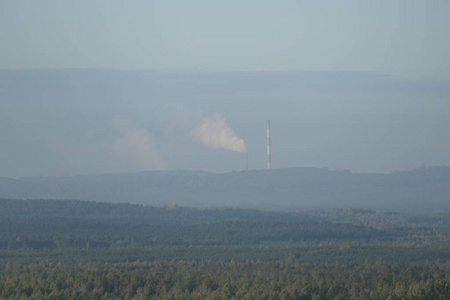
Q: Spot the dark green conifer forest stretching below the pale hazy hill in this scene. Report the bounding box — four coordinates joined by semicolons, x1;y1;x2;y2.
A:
0;199;450;299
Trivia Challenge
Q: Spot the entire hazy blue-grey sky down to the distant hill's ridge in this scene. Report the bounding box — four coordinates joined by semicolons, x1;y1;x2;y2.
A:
0;0;450;177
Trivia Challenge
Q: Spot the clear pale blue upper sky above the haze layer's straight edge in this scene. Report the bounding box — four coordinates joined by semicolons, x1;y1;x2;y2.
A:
0;0;450;79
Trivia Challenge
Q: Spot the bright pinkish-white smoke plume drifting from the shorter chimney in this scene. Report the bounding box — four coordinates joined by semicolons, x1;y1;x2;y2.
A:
189;115;247;153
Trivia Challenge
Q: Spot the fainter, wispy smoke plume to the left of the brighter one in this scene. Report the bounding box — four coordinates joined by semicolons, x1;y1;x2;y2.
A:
113;117;164;170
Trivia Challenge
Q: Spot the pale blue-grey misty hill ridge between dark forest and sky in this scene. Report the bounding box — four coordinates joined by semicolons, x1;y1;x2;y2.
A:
0;166;450;212
